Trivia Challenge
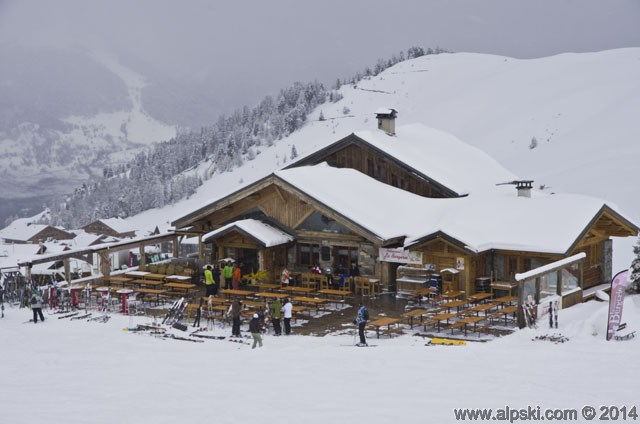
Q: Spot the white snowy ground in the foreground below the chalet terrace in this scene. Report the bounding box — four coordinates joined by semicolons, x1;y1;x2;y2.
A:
0;296;640;424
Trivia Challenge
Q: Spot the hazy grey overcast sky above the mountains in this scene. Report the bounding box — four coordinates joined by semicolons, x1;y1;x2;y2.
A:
0;0;640;116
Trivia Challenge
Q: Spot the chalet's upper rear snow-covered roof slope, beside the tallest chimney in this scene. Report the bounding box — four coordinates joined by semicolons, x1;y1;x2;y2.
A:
354;124;518;195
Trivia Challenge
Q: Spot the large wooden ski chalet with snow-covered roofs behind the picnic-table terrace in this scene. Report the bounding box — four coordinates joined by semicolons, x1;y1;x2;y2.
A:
172;109;640;303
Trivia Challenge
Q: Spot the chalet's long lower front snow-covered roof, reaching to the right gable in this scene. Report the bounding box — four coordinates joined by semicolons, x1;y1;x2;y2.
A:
275;164;636;254
